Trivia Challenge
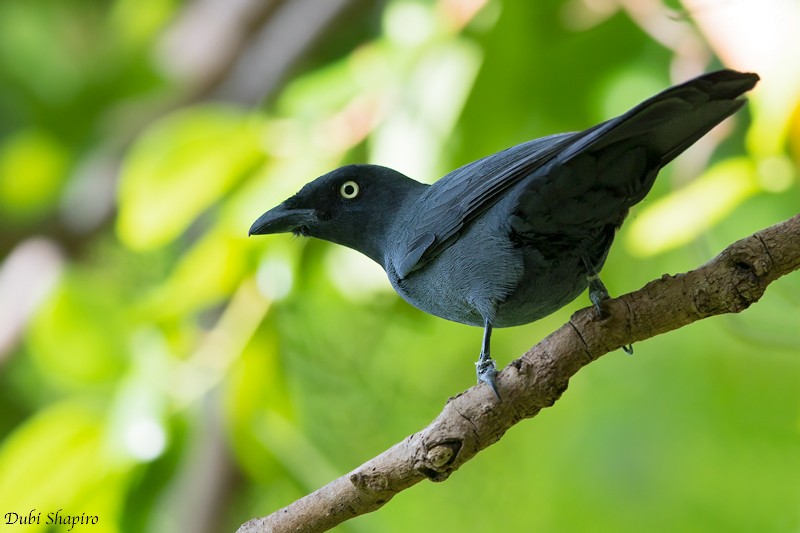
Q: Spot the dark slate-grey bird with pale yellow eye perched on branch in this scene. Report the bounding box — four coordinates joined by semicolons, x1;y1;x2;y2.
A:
250;70;759;398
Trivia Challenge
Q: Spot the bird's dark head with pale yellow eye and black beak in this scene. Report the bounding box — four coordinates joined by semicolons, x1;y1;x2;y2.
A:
249;165;427;266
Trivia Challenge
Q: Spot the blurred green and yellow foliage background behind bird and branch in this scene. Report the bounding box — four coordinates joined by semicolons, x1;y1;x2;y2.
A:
0;0;800;532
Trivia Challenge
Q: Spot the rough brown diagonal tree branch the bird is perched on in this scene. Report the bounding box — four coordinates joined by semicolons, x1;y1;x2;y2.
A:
238;215;800;533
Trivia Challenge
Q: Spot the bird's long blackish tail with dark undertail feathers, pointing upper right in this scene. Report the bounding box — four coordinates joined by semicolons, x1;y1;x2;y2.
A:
518;70;759;234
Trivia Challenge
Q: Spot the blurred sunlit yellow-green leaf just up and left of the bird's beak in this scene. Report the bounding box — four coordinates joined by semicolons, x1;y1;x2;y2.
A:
117;106;264;250
